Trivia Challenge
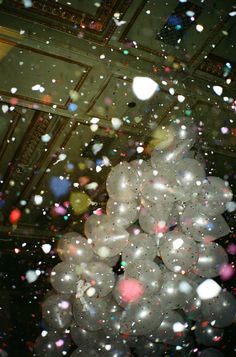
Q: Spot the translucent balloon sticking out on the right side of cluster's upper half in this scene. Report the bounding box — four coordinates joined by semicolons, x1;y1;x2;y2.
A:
195;176;233;217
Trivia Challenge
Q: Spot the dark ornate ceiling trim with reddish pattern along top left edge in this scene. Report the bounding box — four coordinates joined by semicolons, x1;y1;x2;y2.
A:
2;0;133;44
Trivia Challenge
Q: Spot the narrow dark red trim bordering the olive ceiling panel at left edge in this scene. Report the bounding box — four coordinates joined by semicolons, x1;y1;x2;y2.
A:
0;38;92;110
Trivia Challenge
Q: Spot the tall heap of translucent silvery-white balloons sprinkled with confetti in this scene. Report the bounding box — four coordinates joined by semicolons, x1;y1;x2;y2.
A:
35;118;236;357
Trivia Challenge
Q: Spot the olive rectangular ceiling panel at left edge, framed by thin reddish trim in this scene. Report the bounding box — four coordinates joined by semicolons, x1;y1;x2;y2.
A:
0;39;89;108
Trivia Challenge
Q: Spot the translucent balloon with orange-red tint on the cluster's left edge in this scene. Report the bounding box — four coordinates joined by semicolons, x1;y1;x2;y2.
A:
57;232;93;264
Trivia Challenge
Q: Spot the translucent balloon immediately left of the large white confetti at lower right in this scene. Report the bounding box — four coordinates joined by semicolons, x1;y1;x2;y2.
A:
160;272;195;310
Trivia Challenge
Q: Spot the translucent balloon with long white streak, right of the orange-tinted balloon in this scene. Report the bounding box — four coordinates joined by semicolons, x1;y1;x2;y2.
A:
85;216;129;258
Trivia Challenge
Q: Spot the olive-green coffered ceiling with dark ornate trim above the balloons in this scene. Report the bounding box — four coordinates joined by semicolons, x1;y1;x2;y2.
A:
0;0;236;239
